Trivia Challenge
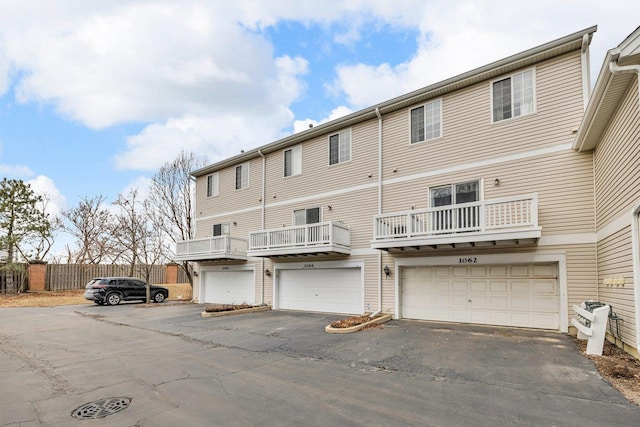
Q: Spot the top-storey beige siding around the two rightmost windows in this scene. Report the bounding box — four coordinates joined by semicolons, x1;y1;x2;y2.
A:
383;52;583;178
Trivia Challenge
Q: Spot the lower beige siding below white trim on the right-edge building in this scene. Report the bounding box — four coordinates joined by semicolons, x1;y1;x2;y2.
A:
598;227;638;347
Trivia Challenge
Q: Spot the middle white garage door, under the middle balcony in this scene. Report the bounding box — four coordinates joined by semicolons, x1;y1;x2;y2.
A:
278;268;363;314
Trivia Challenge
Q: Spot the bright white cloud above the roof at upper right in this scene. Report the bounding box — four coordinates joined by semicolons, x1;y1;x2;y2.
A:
329;0;640;109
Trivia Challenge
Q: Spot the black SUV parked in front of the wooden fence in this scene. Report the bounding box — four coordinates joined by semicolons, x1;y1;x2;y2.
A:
84;277;169;305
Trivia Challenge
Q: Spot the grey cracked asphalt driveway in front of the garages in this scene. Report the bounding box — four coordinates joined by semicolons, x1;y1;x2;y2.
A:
0;304;640;426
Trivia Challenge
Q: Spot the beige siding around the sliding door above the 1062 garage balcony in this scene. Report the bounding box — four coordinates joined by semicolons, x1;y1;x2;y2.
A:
382;150;594;236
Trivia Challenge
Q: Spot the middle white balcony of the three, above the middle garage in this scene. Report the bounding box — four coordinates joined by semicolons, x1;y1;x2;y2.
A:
247;221;351;258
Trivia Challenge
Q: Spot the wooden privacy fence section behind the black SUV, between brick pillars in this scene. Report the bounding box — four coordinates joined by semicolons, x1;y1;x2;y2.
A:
45;264;189;291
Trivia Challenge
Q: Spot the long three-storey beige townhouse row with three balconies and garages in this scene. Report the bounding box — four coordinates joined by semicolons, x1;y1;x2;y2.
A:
176;27;640;358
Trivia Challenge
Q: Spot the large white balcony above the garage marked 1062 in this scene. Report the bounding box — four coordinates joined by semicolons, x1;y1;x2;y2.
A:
371;193;542;251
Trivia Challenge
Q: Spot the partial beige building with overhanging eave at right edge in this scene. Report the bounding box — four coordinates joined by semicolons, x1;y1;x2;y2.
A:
573;27;640;357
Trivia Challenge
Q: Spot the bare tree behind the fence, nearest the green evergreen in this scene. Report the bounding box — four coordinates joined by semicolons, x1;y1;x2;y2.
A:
62;196;114;264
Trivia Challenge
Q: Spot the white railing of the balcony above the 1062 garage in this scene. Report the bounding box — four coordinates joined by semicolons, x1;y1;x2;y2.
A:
374;193;538;241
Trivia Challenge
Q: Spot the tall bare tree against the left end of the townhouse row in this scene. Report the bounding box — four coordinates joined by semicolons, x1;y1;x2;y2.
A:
149;151;204;286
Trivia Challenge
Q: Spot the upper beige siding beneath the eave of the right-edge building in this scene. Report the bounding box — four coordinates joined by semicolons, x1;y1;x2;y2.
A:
594;79;640;228
